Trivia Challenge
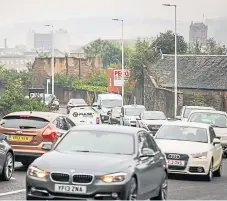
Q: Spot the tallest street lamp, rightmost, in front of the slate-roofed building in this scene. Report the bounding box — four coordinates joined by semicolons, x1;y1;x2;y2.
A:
162;4;177;118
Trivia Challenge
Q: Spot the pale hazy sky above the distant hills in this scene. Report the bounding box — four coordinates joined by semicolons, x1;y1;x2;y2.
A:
0;0;227;25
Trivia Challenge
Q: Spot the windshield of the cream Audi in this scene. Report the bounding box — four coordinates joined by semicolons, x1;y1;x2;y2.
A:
155;125;208;143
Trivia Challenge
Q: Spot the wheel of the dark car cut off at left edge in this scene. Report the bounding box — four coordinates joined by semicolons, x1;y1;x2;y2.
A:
0;152;14;181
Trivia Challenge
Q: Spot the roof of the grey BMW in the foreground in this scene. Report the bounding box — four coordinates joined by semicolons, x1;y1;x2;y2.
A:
71;124;144;135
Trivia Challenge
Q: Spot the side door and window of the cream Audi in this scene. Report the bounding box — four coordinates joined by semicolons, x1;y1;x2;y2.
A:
209;127;222;168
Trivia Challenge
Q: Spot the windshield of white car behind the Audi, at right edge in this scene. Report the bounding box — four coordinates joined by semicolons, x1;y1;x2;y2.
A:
188;112;227;128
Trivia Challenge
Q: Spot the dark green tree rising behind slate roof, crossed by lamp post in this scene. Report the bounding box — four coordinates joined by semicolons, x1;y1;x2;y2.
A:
152;31;187;54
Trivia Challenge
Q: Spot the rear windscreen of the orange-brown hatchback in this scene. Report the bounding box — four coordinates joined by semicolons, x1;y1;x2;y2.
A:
0;116;49;129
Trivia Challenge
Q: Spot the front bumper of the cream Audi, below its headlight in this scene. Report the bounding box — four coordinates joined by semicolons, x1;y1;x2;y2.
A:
168;158;210;175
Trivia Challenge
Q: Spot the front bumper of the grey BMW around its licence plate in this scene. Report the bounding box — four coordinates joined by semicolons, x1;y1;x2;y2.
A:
26;176;129;200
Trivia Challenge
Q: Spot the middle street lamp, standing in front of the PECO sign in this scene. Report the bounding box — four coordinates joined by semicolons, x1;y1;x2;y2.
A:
112;19;125;106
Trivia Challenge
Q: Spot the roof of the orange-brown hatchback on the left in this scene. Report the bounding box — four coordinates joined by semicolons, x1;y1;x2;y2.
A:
4;111;66;121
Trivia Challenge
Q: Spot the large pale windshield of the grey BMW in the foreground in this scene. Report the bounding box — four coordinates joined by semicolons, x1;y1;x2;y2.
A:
56;131;135;155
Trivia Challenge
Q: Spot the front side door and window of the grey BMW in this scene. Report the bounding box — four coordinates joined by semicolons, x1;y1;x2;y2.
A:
137;131;158;195
